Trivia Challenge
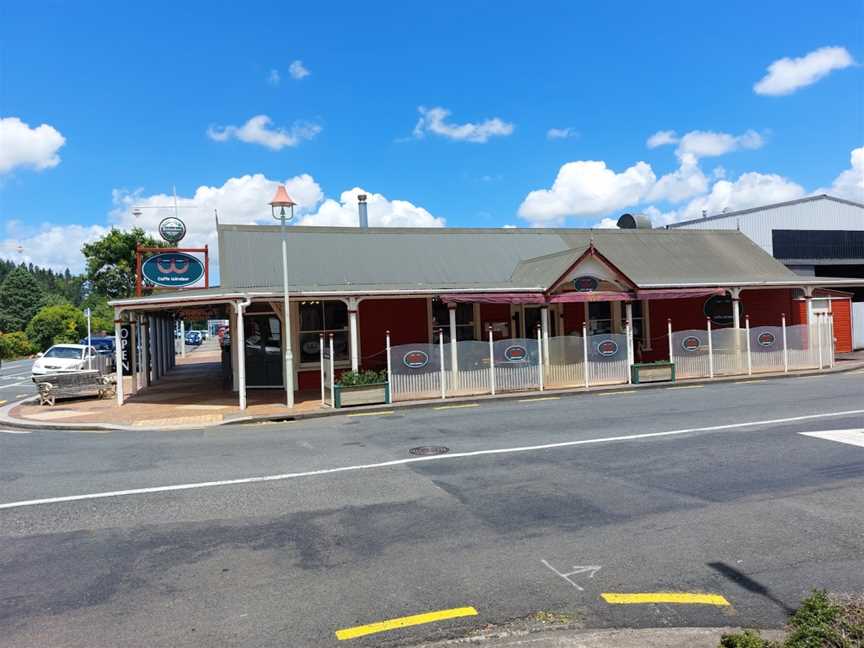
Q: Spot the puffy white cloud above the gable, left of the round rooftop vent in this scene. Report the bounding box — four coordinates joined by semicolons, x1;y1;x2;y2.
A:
519;160;656;226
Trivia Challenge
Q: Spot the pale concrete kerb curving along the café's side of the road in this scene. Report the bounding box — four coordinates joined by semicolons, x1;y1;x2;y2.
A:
0;362;864;432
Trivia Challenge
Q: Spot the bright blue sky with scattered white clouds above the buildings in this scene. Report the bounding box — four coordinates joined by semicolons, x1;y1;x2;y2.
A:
0;1;864;269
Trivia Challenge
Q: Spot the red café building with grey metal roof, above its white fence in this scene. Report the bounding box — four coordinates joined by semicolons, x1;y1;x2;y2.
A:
114;220;864;408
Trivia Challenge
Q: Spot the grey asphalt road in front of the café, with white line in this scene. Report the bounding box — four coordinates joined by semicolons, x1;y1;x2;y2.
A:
0;372;864;648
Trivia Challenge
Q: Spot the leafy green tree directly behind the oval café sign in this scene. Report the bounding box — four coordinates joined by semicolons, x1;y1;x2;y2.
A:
81;227;166;299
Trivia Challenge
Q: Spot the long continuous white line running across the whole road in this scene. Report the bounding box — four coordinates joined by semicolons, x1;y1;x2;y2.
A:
0;409;864;509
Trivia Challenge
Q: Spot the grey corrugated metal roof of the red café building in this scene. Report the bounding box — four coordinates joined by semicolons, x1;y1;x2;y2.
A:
219;225;797;292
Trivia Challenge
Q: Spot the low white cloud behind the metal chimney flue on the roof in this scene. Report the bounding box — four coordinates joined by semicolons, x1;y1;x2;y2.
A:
298;187;445;227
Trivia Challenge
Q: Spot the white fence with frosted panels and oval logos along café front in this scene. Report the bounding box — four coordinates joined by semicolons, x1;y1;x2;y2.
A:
387;315;834;400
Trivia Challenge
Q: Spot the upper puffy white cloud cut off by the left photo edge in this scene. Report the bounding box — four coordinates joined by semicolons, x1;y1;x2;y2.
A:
0;117;66;174
